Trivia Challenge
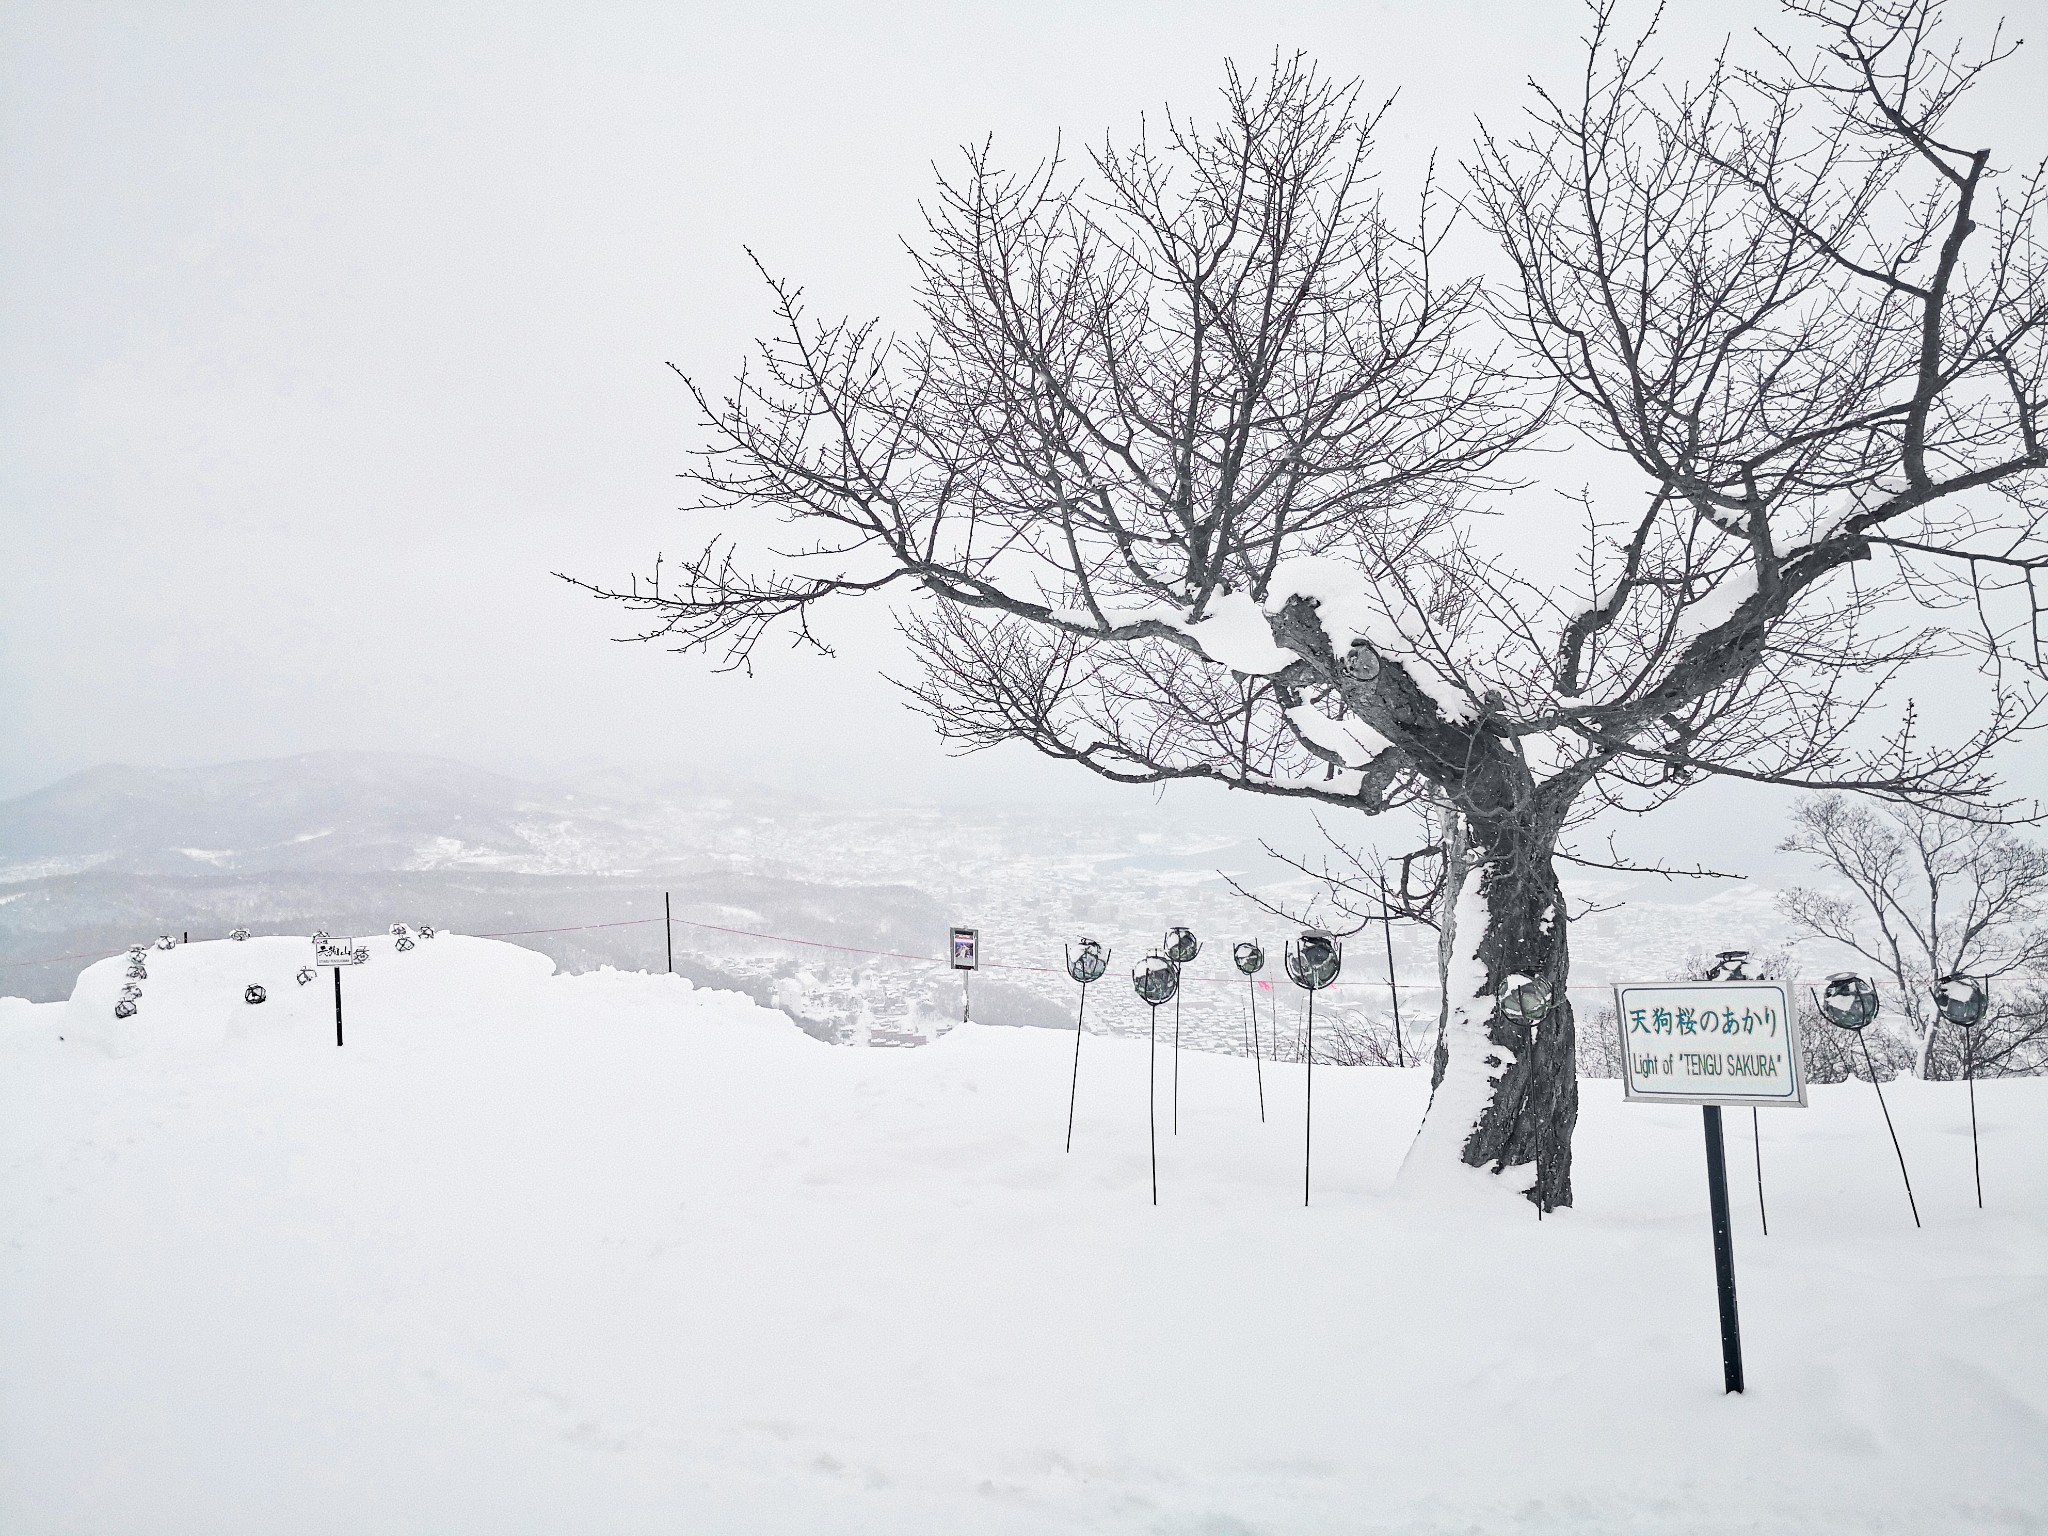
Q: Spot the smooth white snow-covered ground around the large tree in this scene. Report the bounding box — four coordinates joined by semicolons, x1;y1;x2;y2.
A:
0;936;2048;1536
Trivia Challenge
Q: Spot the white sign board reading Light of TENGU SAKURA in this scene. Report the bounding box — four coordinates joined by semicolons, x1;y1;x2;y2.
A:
1614;981;1806;1108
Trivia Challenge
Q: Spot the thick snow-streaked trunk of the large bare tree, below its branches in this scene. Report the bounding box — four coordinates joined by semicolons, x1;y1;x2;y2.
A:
1403;817;1579;1210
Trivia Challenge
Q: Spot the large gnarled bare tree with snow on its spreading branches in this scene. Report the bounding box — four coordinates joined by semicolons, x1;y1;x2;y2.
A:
569;0;2048;1206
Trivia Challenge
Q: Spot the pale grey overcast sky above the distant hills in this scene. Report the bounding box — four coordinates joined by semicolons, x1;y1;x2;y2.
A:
0;0;2048;856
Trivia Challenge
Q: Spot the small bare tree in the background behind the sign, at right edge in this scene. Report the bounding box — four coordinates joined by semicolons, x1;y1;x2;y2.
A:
1780;795;2048;1077
